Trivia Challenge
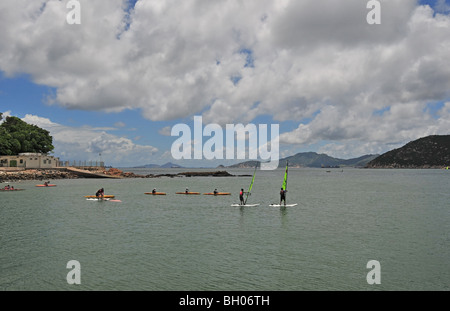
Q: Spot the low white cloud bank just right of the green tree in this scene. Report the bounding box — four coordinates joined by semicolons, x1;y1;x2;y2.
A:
22;114;158;166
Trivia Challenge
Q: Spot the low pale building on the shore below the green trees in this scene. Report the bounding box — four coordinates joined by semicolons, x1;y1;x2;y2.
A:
0;153;59;168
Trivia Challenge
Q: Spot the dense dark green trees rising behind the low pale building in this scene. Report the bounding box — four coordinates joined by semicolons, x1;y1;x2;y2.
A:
0;113;54;155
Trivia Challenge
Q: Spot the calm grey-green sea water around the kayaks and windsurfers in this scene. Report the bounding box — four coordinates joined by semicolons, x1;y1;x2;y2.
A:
0;169;450;291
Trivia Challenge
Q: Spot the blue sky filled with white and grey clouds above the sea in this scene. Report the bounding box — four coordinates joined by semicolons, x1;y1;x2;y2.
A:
0;0;450;167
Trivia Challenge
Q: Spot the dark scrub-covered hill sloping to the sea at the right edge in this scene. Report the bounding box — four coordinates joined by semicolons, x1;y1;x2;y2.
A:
367;135;450;168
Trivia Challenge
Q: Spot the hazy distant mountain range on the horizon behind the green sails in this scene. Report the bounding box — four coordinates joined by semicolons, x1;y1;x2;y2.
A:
228;152;378;168
